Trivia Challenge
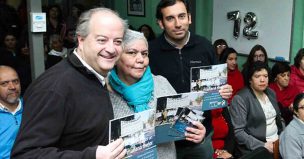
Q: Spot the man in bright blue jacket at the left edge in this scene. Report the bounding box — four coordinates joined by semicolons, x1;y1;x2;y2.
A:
0;65;22;159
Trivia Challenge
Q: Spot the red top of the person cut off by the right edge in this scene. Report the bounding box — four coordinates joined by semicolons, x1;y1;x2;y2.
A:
290;65;304;92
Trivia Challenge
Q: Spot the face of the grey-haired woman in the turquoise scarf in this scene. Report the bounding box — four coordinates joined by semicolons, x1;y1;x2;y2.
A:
117;39;149;85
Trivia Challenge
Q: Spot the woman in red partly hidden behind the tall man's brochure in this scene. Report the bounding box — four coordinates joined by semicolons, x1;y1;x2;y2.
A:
211;48;244;158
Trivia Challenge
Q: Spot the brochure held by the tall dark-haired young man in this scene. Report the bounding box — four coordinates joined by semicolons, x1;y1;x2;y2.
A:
190;63;228;111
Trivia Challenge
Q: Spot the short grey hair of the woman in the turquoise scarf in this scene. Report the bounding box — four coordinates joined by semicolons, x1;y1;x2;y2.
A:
123;29;148;48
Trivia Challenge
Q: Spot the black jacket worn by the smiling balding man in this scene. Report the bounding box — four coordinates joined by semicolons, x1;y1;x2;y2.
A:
11;53;113;159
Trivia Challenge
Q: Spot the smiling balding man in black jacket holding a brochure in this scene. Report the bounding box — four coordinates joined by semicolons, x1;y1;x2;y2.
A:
12;8;127;159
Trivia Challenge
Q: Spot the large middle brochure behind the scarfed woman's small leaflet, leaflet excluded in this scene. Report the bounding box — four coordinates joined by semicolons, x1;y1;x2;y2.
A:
155;92;204;143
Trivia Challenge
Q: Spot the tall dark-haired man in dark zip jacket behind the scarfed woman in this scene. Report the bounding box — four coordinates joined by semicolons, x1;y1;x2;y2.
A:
149;0;232;159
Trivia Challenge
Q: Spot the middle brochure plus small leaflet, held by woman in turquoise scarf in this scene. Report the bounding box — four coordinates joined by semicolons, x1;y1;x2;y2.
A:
155;92;204;144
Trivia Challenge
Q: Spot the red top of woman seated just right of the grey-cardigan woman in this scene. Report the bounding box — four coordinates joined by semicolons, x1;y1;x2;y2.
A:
269;83;300;107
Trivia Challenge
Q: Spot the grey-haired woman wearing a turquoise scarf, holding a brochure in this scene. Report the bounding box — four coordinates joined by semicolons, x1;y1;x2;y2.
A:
108;30;206;158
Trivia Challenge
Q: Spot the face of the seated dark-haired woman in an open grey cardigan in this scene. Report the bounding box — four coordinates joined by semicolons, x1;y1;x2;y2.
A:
249;69;268;92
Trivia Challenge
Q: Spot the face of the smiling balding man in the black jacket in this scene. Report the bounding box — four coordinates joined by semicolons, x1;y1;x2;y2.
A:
77;12;124;76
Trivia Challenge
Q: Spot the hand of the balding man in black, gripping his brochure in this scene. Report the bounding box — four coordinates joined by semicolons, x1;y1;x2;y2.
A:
96;139;127;159
